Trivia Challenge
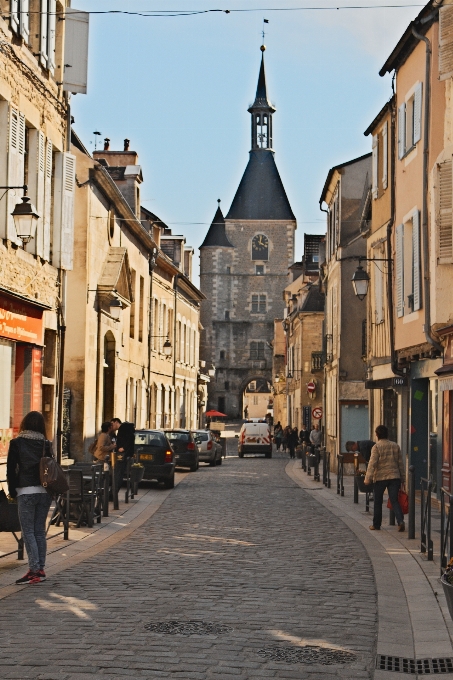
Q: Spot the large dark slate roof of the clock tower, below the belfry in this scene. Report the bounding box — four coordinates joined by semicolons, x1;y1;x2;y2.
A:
225;149;296;220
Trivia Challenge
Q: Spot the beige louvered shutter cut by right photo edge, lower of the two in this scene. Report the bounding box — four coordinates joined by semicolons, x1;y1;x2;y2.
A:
436;158;453;264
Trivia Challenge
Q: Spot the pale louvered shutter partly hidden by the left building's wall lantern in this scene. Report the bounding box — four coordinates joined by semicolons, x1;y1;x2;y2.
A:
26;130;45;257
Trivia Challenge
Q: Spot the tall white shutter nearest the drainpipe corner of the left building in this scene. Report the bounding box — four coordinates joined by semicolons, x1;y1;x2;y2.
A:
52;153;76;269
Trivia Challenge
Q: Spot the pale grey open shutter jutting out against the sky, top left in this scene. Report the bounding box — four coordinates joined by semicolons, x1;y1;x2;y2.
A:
63;7;90;94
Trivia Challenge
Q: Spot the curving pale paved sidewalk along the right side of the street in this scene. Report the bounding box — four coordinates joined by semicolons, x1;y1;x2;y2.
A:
286;460;453;680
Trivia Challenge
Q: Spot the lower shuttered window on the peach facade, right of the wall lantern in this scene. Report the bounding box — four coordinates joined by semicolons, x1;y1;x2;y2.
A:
396;209;422;317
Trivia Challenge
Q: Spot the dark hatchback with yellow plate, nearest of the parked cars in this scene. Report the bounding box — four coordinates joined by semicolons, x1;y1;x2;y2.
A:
134;430;175;489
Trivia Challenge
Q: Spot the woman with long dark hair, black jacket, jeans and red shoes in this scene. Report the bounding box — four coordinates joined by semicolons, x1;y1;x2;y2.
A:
6;411;52;585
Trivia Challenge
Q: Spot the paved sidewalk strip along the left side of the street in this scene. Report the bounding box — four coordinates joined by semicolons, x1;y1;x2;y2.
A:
0;473;187;600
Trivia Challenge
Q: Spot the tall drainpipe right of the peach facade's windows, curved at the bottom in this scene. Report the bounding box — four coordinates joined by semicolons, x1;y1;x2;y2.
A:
412;17;443;354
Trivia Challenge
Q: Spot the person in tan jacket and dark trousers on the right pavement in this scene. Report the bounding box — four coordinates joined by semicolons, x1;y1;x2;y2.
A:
365;425;406;531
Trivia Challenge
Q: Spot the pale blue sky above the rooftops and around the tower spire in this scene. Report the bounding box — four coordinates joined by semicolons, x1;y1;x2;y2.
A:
71;0;422;284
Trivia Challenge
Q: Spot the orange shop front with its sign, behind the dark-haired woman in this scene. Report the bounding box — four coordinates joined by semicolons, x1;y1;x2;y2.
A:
0;292;44;462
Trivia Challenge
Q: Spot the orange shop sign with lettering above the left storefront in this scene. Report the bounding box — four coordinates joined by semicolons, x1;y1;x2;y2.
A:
0;295;43;345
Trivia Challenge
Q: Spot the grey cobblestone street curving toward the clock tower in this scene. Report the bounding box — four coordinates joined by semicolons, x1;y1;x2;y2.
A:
0;448;377;680
